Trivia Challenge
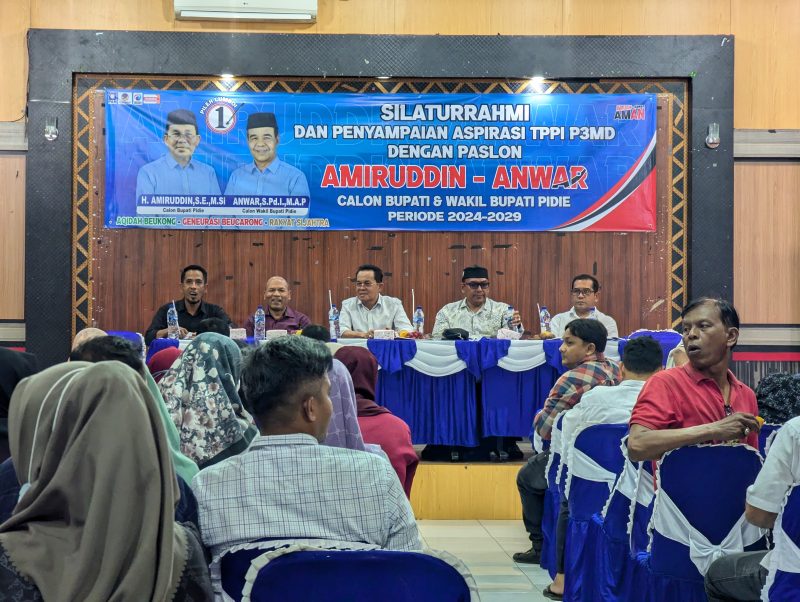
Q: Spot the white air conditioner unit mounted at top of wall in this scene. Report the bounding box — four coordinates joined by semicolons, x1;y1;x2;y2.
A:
174;0;317;23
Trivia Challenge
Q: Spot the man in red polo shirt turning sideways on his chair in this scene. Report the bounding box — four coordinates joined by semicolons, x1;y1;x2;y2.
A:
628;297;759;462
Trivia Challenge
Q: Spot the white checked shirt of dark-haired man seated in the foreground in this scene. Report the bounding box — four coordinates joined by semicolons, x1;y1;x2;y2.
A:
192;433;422;557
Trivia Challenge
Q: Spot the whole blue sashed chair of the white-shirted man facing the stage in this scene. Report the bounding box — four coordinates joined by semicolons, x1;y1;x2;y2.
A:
562;424;628;601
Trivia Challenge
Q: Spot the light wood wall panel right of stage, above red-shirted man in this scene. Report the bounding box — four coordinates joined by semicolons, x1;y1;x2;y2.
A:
733;161;800;324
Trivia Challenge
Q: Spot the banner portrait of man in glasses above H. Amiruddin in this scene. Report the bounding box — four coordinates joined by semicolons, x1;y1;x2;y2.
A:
136;109;221;201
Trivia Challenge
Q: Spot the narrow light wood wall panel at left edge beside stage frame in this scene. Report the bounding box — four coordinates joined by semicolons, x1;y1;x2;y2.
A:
0;154;25;320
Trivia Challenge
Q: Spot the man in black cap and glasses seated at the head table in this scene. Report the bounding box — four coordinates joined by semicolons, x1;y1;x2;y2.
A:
431;265;522;339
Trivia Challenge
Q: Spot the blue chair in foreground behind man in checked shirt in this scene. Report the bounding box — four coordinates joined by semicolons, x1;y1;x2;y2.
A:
242;550;471;602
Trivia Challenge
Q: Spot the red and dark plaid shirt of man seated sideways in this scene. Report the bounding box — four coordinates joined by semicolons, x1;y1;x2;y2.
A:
533;353;622;439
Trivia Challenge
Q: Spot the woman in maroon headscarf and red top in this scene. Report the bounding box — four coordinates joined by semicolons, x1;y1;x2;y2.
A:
336;345;419;498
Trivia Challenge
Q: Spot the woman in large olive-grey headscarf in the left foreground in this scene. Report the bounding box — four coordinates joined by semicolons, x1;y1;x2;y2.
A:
0;362;212;602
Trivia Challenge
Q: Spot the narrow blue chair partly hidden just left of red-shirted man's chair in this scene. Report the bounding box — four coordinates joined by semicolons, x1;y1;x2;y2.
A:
589;440;652;600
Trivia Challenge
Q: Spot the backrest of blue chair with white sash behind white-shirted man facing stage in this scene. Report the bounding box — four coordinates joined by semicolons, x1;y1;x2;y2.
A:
564;424;628;521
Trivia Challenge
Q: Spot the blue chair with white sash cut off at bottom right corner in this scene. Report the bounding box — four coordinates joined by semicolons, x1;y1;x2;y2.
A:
767;485;800;602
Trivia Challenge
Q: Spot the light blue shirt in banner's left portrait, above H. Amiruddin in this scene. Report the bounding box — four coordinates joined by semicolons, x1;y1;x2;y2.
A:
136;153;222;201
